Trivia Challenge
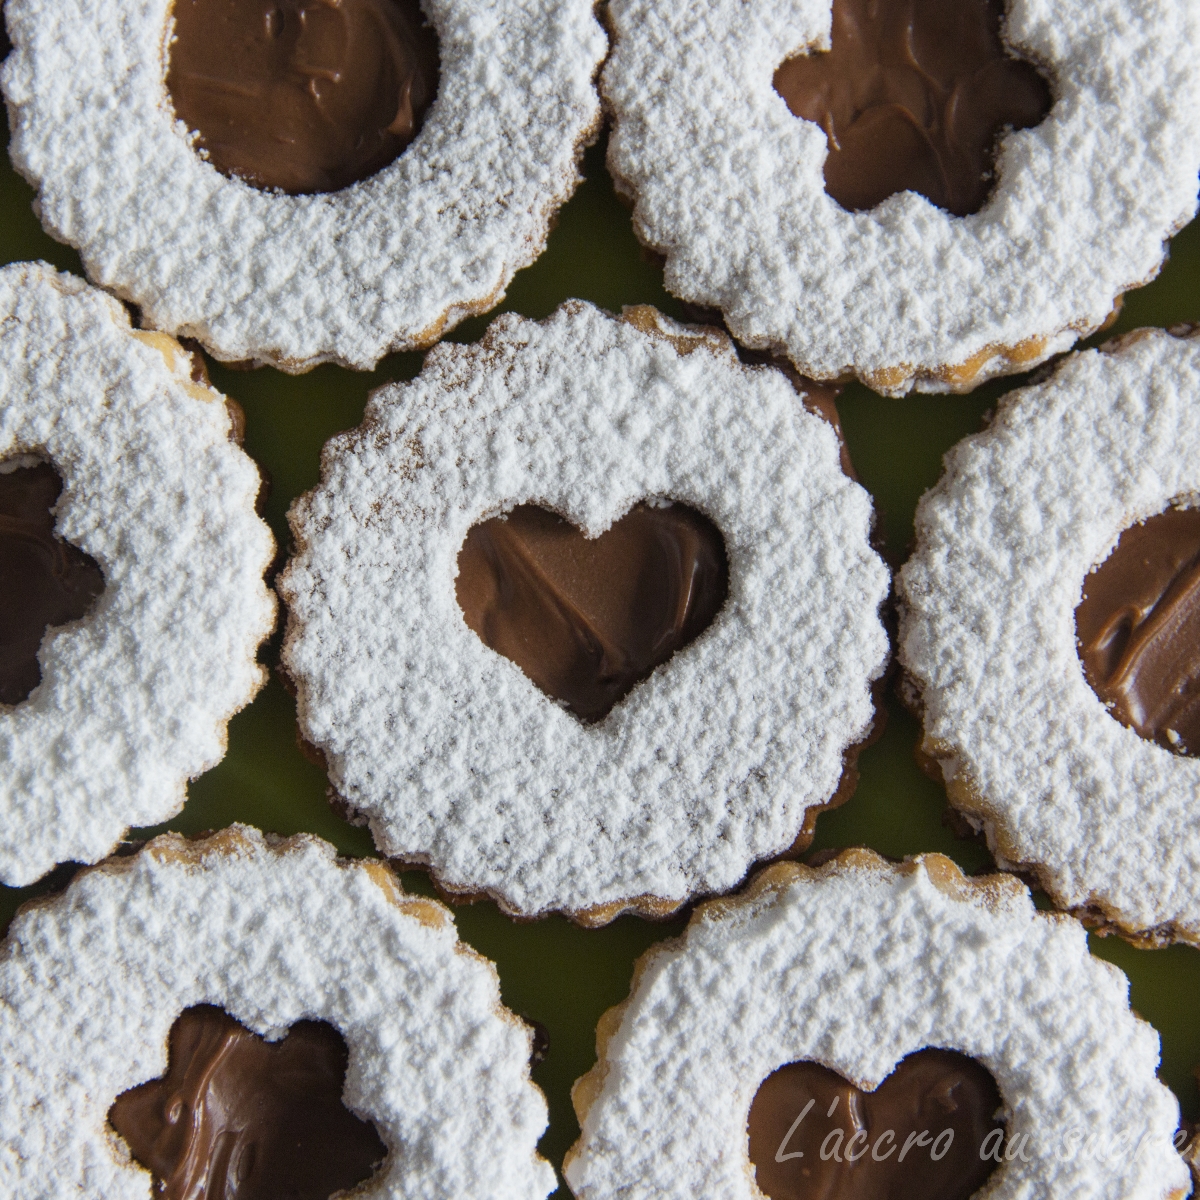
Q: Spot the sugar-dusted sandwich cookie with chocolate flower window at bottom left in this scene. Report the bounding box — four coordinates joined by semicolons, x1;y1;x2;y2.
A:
0;826;554;1200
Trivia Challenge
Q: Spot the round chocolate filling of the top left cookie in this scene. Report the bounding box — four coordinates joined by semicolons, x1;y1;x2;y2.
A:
167;0;438;196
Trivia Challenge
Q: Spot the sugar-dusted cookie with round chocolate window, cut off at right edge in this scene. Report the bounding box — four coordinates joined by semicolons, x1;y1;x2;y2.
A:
898;330;1200;944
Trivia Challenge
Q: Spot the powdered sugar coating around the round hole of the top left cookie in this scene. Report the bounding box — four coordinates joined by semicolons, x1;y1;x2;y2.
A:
2;0;606;371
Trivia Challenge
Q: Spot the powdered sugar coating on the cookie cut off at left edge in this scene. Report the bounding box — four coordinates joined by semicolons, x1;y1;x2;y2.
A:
0;263;275;886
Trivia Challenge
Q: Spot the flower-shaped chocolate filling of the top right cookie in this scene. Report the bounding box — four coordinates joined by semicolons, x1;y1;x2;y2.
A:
775;0;1050;216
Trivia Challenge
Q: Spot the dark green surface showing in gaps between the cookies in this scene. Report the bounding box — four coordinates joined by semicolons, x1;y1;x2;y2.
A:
0;105;1200;1198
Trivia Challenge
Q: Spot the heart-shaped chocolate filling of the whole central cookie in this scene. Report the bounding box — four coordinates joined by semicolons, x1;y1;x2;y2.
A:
455;504;728;721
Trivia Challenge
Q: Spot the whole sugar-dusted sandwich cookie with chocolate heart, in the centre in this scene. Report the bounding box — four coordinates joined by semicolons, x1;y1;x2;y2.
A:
280;301;888;924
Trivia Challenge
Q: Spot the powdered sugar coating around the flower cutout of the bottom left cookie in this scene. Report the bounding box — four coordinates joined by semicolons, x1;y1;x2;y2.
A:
0;826;554;1200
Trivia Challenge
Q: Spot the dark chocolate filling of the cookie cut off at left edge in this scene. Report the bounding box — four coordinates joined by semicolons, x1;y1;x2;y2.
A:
0;463;104;704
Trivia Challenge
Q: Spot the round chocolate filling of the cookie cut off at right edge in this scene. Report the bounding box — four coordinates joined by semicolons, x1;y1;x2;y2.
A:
1075;509;1200;755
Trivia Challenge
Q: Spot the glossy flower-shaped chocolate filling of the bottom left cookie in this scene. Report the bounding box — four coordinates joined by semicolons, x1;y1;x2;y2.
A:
108;1004;386;1200
